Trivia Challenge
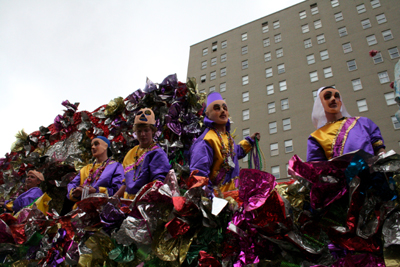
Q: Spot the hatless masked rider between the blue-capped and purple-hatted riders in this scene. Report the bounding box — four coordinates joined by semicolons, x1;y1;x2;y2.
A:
116;108;171;199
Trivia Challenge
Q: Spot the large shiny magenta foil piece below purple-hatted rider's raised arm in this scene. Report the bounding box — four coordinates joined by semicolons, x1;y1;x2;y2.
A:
239;169;276;211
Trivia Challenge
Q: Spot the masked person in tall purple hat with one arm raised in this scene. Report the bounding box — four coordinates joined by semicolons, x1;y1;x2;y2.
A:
190;92;260;192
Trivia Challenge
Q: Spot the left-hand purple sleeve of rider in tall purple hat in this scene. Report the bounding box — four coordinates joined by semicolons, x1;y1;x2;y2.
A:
190;140;214;177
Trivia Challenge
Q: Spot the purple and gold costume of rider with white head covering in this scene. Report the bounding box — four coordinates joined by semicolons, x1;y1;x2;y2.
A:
307;117;385;161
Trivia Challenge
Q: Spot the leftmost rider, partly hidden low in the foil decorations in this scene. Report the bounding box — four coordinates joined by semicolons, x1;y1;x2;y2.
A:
5;170;44;213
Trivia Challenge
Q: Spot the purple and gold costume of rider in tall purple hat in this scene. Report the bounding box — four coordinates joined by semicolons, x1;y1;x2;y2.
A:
190;117;254;191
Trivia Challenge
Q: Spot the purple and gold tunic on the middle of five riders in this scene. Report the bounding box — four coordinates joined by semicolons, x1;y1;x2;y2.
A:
123;145;171;198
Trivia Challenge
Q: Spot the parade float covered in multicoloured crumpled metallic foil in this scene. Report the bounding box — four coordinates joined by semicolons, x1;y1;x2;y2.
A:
0;75;400;267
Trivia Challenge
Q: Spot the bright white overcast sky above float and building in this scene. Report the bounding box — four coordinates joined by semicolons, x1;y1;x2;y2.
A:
0;0;302;158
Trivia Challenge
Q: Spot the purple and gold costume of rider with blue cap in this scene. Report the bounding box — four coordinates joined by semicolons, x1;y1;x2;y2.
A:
67;160;124;201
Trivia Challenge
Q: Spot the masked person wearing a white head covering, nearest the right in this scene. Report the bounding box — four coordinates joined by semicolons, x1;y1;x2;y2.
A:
307;86;385;162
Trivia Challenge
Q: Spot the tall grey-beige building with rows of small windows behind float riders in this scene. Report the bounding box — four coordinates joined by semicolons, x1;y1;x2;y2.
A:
188;0;400;182
